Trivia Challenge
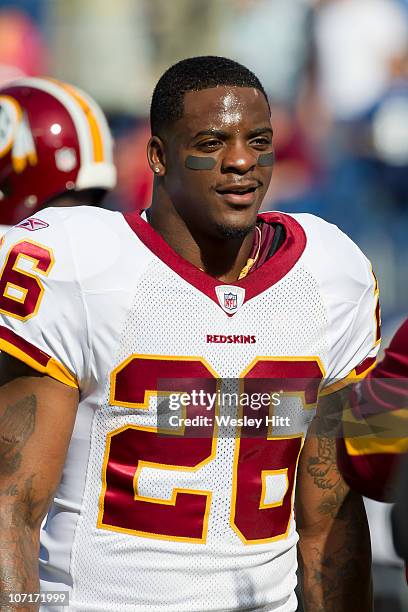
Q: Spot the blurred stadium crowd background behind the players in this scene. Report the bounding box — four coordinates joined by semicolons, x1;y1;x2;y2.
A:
0;0;408;612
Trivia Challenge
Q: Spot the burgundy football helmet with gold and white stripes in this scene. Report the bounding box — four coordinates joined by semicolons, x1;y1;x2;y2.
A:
0;78;116;225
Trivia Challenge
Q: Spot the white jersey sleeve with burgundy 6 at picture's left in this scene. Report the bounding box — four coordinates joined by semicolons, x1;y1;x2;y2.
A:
0;209;89;388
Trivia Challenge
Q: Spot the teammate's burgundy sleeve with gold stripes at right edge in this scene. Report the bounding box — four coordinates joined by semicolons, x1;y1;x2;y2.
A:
338;320;408;501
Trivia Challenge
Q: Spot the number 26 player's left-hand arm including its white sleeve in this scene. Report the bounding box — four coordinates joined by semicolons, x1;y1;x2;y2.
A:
0;211;88;610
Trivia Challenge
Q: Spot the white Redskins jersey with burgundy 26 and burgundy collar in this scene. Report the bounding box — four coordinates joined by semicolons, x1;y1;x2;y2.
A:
0;206;378;612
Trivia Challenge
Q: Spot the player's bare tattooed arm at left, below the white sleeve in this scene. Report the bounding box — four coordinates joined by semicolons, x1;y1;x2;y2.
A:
0;353;78;611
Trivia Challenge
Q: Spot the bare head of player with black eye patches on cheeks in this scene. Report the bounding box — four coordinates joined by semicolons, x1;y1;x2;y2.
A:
148;56;273;237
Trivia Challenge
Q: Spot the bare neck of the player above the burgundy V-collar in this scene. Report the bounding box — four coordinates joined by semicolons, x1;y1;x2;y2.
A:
147;206;255;283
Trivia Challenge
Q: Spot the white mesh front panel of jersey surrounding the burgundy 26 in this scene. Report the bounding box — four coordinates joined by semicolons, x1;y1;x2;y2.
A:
67;259;328;612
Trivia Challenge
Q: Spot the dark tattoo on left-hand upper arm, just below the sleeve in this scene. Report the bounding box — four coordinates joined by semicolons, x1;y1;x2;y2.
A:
0;395;37;476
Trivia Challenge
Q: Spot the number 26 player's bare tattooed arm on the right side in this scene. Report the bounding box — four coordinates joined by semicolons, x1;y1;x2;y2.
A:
296;392;372;612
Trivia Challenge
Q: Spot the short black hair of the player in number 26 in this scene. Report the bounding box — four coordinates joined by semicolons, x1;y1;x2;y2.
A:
150;55;269;136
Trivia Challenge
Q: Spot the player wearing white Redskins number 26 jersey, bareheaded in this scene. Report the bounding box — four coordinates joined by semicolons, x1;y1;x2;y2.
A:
0;57;377;612
